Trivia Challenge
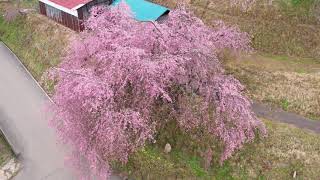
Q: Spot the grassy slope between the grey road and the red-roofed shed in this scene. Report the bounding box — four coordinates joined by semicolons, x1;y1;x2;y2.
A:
0;4;72;80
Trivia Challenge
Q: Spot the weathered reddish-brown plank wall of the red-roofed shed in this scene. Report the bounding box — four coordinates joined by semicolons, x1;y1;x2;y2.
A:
39;1;83;32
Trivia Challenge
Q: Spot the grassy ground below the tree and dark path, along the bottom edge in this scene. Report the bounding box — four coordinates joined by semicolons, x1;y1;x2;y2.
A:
116;120;320;180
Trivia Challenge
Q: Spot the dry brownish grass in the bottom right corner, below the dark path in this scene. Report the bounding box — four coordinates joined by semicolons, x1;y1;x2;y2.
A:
230;120;320;180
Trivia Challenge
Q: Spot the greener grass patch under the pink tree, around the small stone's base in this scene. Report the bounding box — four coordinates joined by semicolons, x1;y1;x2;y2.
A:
115;145;228;179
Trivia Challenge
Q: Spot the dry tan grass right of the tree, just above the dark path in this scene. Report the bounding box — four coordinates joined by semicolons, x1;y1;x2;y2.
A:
226;56;320;119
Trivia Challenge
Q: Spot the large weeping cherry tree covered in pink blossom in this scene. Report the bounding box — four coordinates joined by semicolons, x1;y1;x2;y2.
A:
50;4;266;179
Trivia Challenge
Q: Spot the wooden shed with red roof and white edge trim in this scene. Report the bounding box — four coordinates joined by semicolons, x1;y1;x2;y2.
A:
39;0;112;32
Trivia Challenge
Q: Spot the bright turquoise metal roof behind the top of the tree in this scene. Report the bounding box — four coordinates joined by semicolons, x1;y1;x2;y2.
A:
112;0;169;21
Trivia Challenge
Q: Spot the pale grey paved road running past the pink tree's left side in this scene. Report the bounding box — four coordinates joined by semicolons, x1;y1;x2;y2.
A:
0;42;75;180
